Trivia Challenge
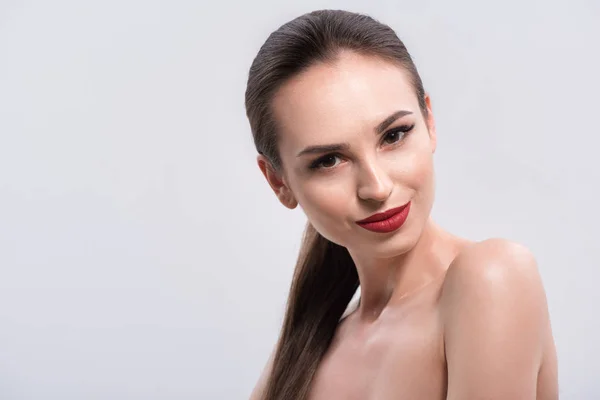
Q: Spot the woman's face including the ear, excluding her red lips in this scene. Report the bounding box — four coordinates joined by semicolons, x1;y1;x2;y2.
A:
258;52;436;257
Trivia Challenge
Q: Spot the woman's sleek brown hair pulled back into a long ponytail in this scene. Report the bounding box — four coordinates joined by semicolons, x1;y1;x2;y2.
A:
246;10;427;400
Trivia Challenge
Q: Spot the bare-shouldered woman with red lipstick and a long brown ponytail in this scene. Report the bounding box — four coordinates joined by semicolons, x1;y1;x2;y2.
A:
246;10;558;400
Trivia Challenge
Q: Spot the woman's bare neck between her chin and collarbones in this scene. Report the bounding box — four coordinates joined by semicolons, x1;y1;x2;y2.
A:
349;219;459;321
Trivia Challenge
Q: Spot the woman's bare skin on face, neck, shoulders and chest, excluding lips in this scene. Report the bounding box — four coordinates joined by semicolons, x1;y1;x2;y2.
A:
251;51;558;400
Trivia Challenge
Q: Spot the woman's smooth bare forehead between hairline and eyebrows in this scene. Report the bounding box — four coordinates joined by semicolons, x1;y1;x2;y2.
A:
272;52;418;150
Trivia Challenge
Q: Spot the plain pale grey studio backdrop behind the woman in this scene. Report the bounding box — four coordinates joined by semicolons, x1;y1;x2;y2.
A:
0;0;600;400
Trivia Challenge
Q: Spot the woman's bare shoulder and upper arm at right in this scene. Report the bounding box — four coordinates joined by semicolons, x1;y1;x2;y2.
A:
441;239;549;400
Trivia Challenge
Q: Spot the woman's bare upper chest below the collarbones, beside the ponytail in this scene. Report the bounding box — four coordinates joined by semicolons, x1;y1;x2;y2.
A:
310;300;447;400
